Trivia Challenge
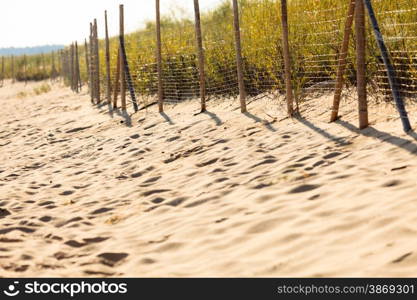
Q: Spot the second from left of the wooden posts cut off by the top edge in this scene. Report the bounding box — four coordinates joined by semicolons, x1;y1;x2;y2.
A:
194;0;206;112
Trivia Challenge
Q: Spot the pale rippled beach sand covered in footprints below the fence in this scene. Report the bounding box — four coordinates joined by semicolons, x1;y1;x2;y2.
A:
0;79;417;277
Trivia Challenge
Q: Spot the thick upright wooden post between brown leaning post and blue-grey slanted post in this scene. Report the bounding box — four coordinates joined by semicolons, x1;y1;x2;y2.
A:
355;0;368;129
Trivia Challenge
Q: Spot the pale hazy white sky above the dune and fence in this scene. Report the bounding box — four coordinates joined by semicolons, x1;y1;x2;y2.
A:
0;0;224;48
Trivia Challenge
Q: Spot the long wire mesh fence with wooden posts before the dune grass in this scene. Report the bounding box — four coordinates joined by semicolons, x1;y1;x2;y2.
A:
1;0;417;129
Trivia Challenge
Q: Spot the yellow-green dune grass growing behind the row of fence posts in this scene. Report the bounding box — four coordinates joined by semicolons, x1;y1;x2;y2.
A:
2;0;417;100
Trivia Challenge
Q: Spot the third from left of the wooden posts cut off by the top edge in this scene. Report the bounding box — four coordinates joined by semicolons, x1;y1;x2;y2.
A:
233;0;247;113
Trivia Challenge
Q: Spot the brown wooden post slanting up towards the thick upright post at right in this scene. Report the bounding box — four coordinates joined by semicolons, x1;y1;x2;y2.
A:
330;0;355;122
